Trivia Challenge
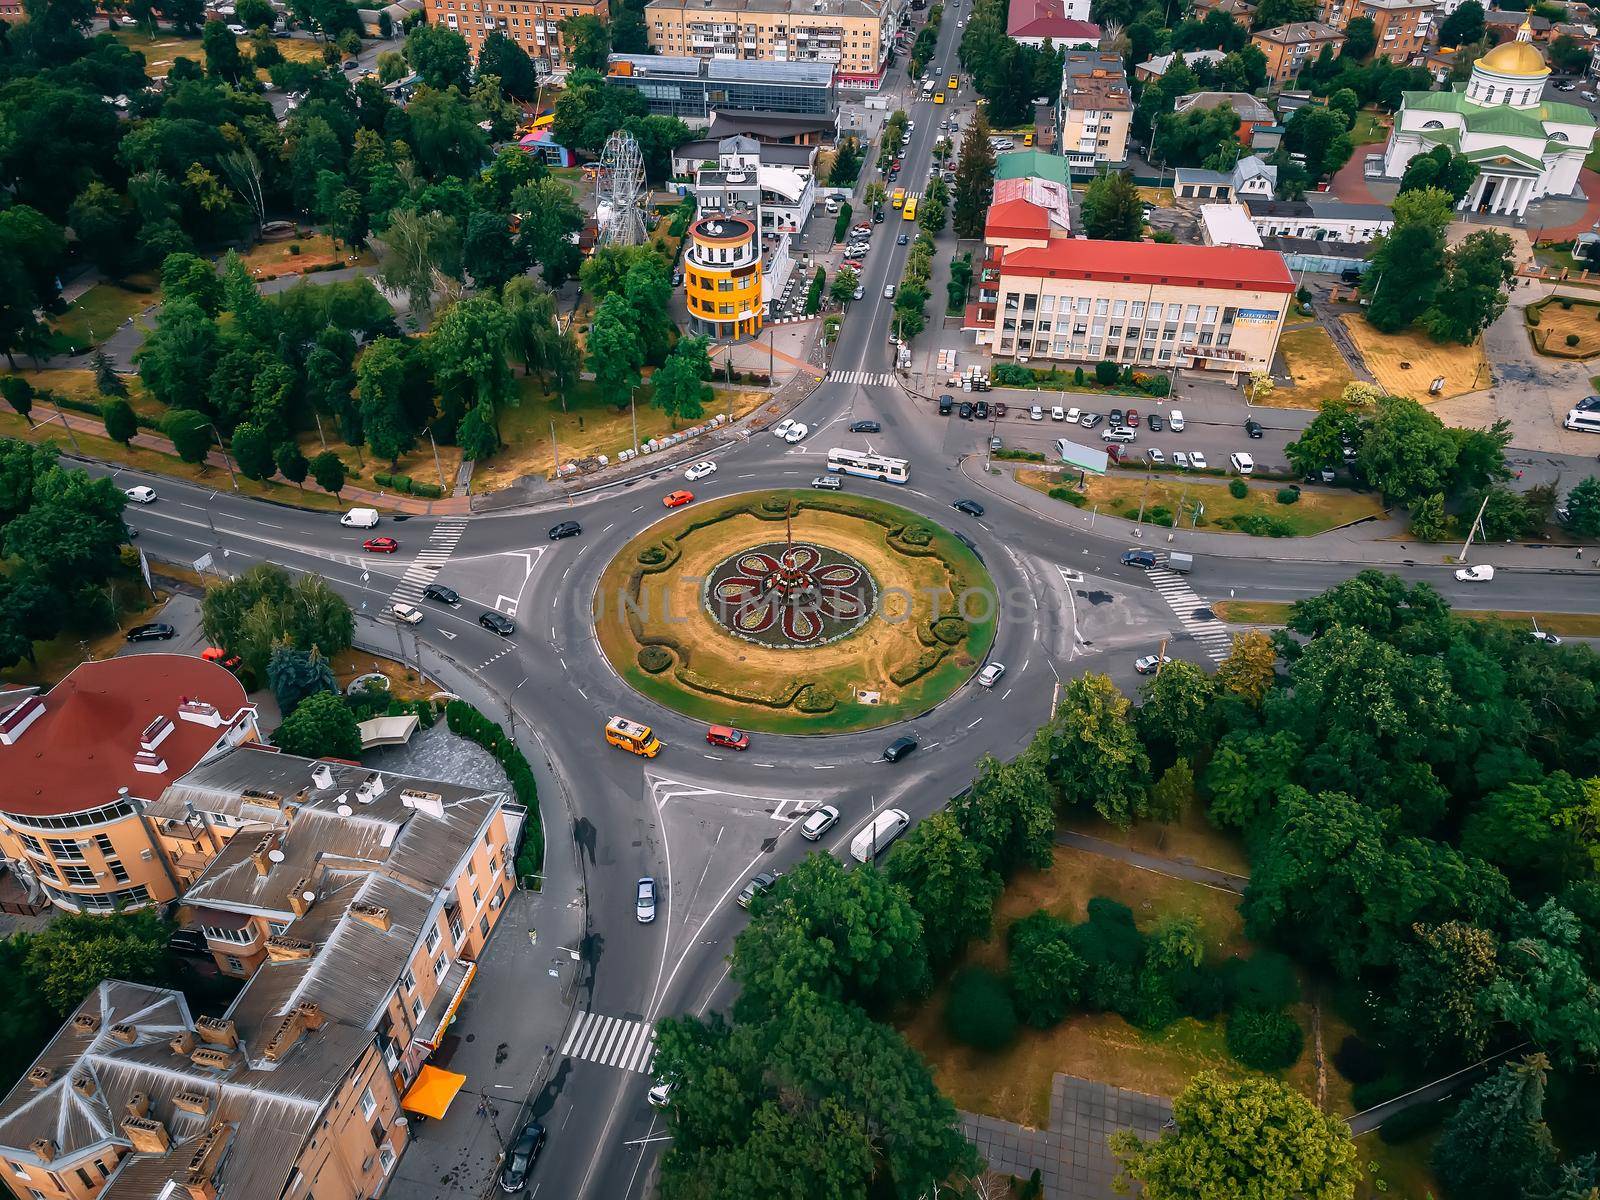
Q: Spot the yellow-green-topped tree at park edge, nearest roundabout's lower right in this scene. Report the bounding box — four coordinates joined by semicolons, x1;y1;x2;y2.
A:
1042;675;1150;829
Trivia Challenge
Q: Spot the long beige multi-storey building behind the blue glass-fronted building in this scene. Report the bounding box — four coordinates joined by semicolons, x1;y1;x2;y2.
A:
645;0;904;90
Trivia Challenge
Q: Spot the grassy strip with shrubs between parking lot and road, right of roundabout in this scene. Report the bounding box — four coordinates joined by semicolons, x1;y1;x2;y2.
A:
1016;469;1384;538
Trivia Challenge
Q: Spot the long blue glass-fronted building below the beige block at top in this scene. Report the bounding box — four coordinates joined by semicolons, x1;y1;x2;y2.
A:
606;54;834;126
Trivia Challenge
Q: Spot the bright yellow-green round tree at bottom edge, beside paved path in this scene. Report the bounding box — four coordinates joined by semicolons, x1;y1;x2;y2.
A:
1110;1075;1360;1200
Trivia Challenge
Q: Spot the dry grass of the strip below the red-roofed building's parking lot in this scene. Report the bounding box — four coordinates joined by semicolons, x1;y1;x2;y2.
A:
1016;470;1382;538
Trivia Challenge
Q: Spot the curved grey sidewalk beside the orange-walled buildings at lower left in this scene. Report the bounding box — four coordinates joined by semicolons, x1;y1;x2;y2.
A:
357;619;587;1200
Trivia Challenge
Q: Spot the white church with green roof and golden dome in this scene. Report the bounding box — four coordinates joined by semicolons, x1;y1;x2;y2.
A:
1384;22;1595;216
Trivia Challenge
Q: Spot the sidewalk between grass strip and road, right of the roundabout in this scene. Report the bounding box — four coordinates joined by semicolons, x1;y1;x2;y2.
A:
960;454;1595;574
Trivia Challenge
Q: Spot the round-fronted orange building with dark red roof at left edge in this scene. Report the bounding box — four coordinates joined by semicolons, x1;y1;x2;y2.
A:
0;654;261;912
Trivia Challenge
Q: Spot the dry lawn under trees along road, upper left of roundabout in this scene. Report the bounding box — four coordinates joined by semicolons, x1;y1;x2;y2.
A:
467;376;768;491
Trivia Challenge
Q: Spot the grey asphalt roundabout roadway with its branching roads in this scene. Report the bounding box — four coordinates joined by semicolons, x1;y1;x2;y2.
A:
84;21;1600;1200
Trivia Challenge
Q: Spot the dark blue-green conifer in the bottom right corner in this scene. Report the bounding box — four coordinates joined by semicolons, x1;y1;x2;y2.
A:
1434;1054;1555;1200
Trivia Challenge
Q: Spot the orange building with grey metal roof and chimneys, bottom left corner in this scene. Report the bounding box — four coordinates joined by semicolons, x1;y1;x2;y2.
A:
0;979;406;1200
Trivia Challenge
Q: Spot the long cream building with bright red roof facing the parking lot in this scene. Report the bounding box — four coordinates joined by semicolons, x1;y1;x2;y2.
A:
965;240;1294;381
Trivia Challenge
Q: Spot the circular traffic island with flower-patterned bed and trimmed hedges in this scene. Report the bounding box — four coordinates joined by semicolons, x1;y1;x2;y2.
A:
594;491;998;733
